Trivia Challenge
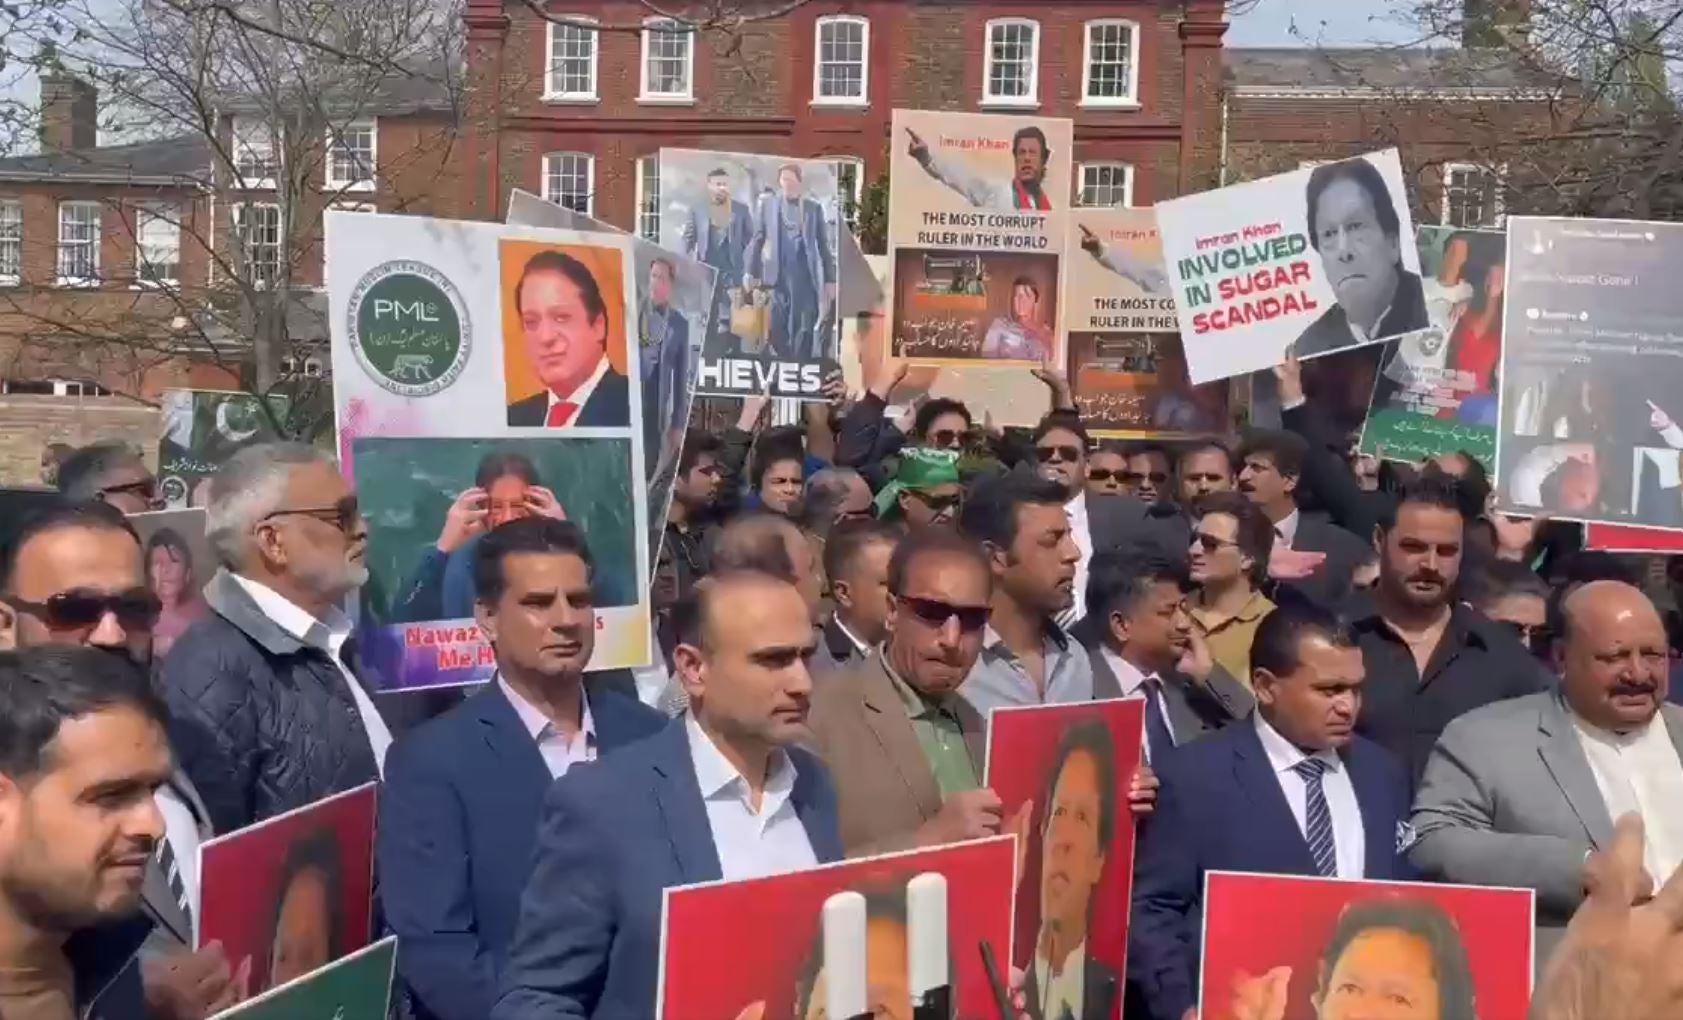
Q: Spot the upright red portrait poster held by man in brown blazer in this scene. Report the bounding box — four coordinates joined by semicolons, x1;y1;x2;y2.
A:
986;699;1144;1020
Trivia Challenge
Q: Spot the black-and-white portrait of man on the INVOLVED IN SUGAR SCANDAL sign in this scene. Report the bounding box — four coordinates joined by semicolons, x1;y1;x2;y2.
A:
1296;158;1427;357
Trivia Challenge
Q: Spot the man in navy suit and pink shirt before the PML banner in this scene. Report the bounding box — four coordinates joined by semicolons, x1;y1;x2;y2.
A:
377;517;665;1020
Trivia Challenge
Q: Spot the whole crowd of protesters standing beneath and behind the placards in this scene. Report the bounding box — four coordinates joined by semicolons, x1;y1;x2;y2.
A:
0;348;1683;1020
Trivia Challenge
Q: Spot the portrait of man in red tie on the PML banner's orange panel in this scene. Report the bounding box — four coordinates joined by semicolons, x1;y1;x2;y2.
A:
503;251;631;429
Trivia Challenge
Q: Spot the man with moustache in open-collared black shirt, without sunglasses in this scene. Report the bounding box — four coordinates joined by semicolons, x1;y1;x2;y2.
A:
1351;471;1545;779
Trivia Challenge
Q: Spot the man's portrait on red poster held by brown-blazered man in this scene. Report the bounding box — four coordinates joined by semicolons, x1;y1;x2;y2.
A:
1023;722;1118;1020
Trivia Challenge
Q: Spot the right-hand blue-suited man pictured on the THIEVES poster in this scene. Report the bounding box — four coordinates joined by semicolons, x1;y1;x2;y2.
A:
742;163;836;359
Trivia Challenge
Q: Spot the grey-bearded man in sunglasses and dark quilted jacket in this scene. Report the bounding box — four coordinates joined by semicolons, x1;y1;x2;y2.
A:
162;443;392;831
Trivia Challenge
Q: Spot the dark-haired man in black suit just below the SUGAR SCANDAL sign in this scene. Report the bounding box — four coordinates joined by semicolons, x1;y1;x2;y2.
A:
1239;429;1372;606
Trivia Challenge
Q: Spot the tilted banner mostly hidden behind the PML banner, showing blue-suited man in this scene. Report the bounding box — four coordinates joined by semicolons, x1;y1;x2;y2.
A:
508;189;717;560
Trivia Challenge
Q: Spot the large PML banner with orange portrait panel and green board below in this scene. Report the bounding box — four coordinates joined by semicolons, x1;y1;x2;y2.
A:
327;212;650;690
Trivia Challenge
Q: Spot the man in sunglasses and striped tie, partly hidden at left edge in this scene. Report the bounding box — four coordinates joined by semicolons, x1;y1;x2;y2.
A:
0;502;249;1020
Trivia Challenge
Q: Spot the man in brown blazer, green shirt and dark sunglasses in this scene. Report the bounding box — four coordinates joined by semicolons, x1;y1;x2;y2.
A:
810;529;1027;857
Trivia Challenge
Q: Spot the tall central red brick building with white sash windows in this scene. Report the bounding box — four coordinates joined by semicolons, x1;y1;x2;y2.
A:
463;0;1227;236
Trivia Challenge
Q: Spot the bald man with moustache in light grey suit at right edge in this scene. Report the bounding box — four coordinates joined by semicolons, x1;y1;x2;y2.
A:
1409;581;1683;961
